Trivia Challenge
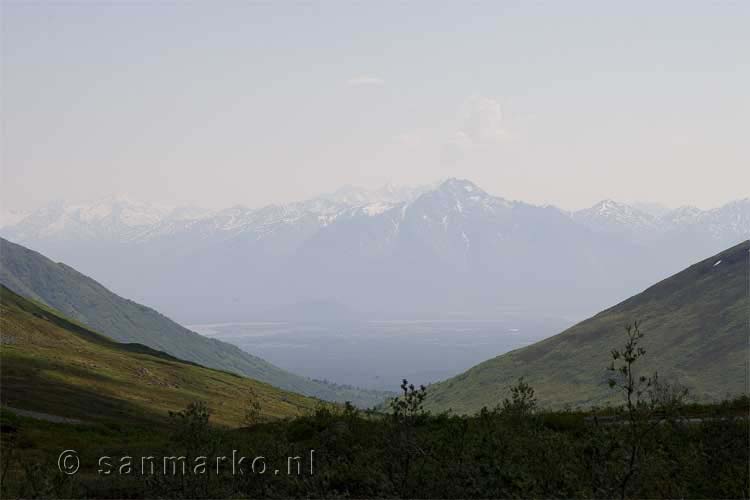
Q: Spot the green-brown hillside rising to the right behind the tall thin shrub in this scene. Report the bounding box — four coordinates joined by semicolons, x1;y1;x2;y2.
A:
427;241;750;413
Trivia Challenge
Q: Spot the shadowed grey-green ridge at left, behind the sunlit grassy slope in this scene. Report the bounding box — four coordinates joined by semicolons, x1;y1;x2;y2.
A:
0;238;386;406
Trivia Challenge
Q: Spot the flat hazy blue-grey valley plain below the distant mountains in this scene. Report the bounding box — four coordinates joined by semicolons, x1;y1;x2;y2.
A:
188;316;573;390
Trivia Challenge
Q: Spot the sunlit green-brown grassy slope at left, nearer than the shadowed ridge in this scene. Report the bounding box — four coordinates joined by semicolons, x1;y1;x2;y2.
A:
0;286;316;425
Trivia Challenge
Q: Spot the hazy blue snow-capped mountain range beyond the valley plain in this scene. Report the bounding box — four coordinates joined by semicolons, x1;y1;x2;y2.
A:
0;179;750;323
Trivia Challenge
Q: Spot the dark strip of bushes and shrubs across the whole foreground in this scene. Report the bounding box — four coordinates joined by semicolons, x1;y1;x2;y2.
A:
0;316;750;498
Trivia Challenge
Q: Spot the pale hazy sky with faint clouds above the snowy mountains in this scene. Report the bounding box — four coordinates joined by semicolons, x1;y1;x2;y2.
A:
0;1;750;208
